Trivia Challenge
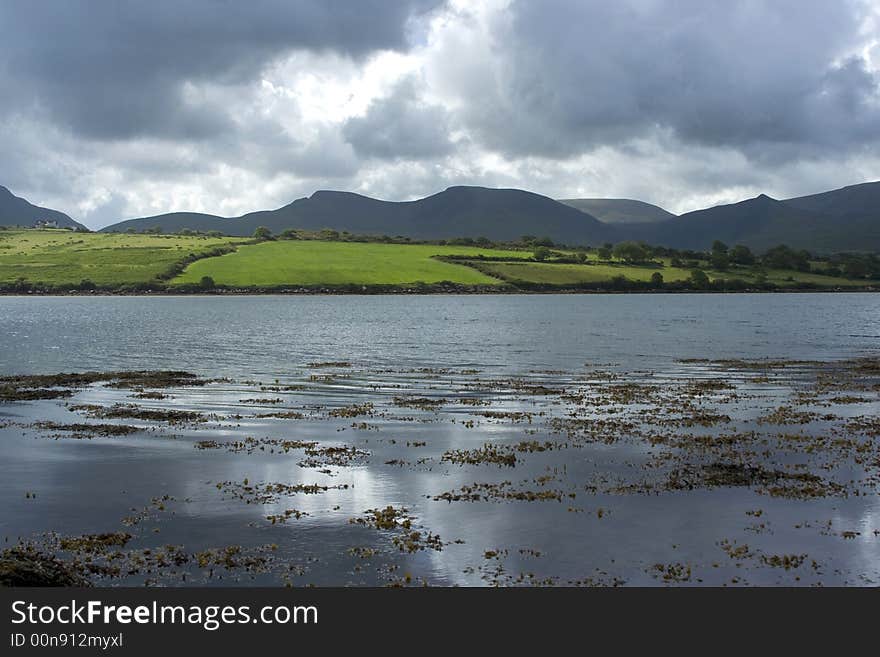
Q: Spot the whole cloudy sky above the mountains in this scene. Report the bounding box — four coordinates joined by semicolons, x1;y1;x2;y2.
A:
0;0;880;228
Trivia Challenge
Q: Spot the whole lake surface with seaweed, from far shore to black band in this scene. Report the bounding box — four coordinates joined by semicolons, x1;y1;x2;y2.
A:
0;293;880;585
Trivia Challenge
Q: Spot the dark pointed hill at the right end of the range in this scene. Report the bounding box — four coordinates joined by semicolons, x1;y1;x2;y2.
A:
618;182;880;252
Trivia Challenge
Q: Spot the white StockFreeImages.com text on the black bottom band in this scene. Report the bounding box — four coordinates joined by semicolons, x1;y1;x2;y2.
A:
12;600;318;632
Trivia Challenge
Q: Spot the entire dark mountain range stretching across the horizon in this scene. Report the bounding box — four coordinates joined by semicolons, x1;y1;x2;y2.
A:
0;182;880;252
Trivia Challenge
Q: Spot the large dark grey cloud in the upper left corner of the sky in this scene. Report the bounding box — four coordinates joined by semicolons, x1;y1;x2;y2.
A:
0;0;440;139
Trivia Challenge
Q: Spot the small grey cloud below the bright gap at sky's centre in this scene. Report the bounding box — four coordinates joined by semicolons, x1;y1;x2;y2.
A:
342;77;453;160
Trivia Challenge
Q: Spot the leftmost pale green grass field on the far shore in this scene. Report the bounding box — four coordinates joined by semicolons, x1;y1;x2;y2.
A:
0;230;242;285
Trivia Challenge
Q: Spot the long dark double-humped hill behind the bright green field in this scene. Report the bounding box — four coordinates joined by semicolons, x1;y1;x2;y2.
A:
103;187;618;244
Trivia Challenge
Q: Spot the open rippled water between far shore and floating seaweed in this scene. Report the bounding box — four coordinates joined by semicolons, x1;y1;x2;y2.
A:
0;294;880;376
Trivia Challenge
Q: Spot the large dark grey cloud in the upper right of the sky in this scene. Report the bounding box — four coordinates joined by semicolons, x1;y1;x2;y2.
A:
454;0;880;157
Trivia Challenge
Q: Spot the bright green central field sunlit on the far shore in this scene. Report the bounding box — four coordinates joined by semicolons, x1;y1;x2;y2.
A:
172;241;531;287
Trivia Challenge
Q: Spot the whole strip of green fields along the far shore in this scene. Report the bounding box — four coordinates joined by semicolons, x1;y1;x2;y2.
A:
0;229;880;292
